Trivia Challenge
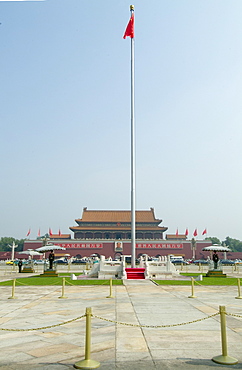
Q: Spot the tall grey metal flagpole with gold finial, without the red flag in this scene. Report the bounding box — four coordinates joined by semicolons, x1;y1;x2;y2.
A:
130;5;136;268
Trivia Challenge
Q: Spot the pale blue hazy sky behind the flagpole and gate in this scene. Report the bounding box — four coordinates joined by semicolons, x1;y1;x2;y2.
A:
0;0;242;240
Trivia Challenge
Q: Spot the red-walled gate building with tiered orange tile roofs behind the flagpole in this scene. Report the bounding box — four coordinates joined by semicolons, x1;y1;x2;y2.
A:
24;207;215;259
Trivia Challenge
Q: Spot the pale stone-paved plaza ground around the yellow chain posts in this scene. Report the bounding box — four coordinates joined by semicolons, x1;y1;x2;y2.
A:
0;276;242;370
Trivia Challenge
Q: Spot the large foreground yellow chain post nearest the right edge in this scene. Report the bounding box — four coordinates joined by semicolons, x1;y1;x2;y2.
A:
212;306;238;365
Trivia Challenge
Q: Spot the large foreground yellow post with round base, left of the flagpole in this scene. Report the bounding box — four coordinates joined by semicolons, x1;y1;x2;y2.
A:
74;307;100;369
